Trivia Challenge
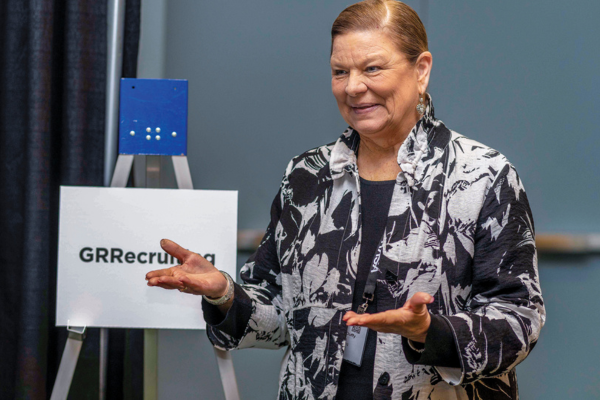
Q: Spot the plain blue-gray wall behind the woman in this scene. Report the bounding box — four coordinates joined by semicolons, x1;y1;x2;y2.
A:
140;0;600;399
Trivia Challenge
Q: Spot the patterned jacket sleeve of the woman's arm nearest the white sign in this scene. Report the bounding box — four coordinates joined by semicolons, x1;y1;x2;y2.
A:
207;184;289;350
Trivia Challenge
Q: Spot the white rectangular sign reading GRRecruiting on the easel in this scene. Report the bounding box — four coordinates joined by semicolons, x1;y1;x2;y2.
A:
56;186;237;329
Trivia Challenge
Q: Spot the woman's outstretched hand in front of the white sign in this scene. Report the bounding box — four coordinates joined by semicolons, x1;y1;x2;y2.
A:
146;239;227;298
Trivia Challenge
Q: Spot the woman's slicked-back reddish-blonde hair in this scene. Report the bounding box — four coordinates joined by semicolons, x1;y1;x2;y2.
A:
331;0;428;64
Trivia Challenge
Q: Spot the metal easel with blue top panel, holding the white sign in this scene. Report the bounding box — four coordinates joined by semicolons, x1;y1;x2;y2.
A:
50;79;240;400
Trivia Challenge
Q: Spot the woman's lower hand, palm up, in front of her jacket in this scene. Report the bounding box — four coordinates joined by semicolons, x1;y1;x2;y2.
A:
343;292;433;343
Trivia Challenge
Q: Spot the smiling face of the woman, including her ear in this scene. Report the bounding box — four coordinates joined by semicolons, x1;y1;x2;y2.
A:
331;30;431;141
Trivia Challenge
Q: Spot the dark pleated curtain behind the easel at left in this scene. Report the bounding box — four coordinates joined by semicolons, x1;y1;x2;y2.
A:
0;0;142;399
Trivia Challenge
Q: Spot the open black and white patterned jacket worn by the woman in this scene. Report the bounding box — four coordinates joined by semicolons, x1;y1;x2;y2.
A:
208;103;545;400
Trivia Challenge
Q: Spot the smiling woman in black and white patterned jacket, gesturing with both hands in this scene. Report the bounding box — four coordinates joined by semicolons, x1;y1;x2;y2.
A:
147;0;545;399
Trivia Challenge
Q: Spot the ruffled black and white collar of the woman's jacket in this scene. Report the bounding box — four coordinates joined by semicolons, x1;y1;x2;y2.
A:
330;94;436;187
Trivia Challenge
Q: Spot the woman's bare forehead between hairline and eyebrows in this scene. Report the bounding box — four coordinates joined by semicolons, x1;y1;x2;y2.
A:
331;30;404;63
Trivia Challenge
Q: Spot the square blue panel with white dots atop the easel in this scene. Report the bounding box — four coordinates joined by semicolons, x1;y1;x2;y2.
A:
119;78;188;156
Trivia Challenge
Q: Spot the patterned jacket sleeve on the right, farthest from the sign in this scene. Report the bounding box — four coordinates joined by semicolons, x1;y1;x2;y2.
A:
436;163;545;385
